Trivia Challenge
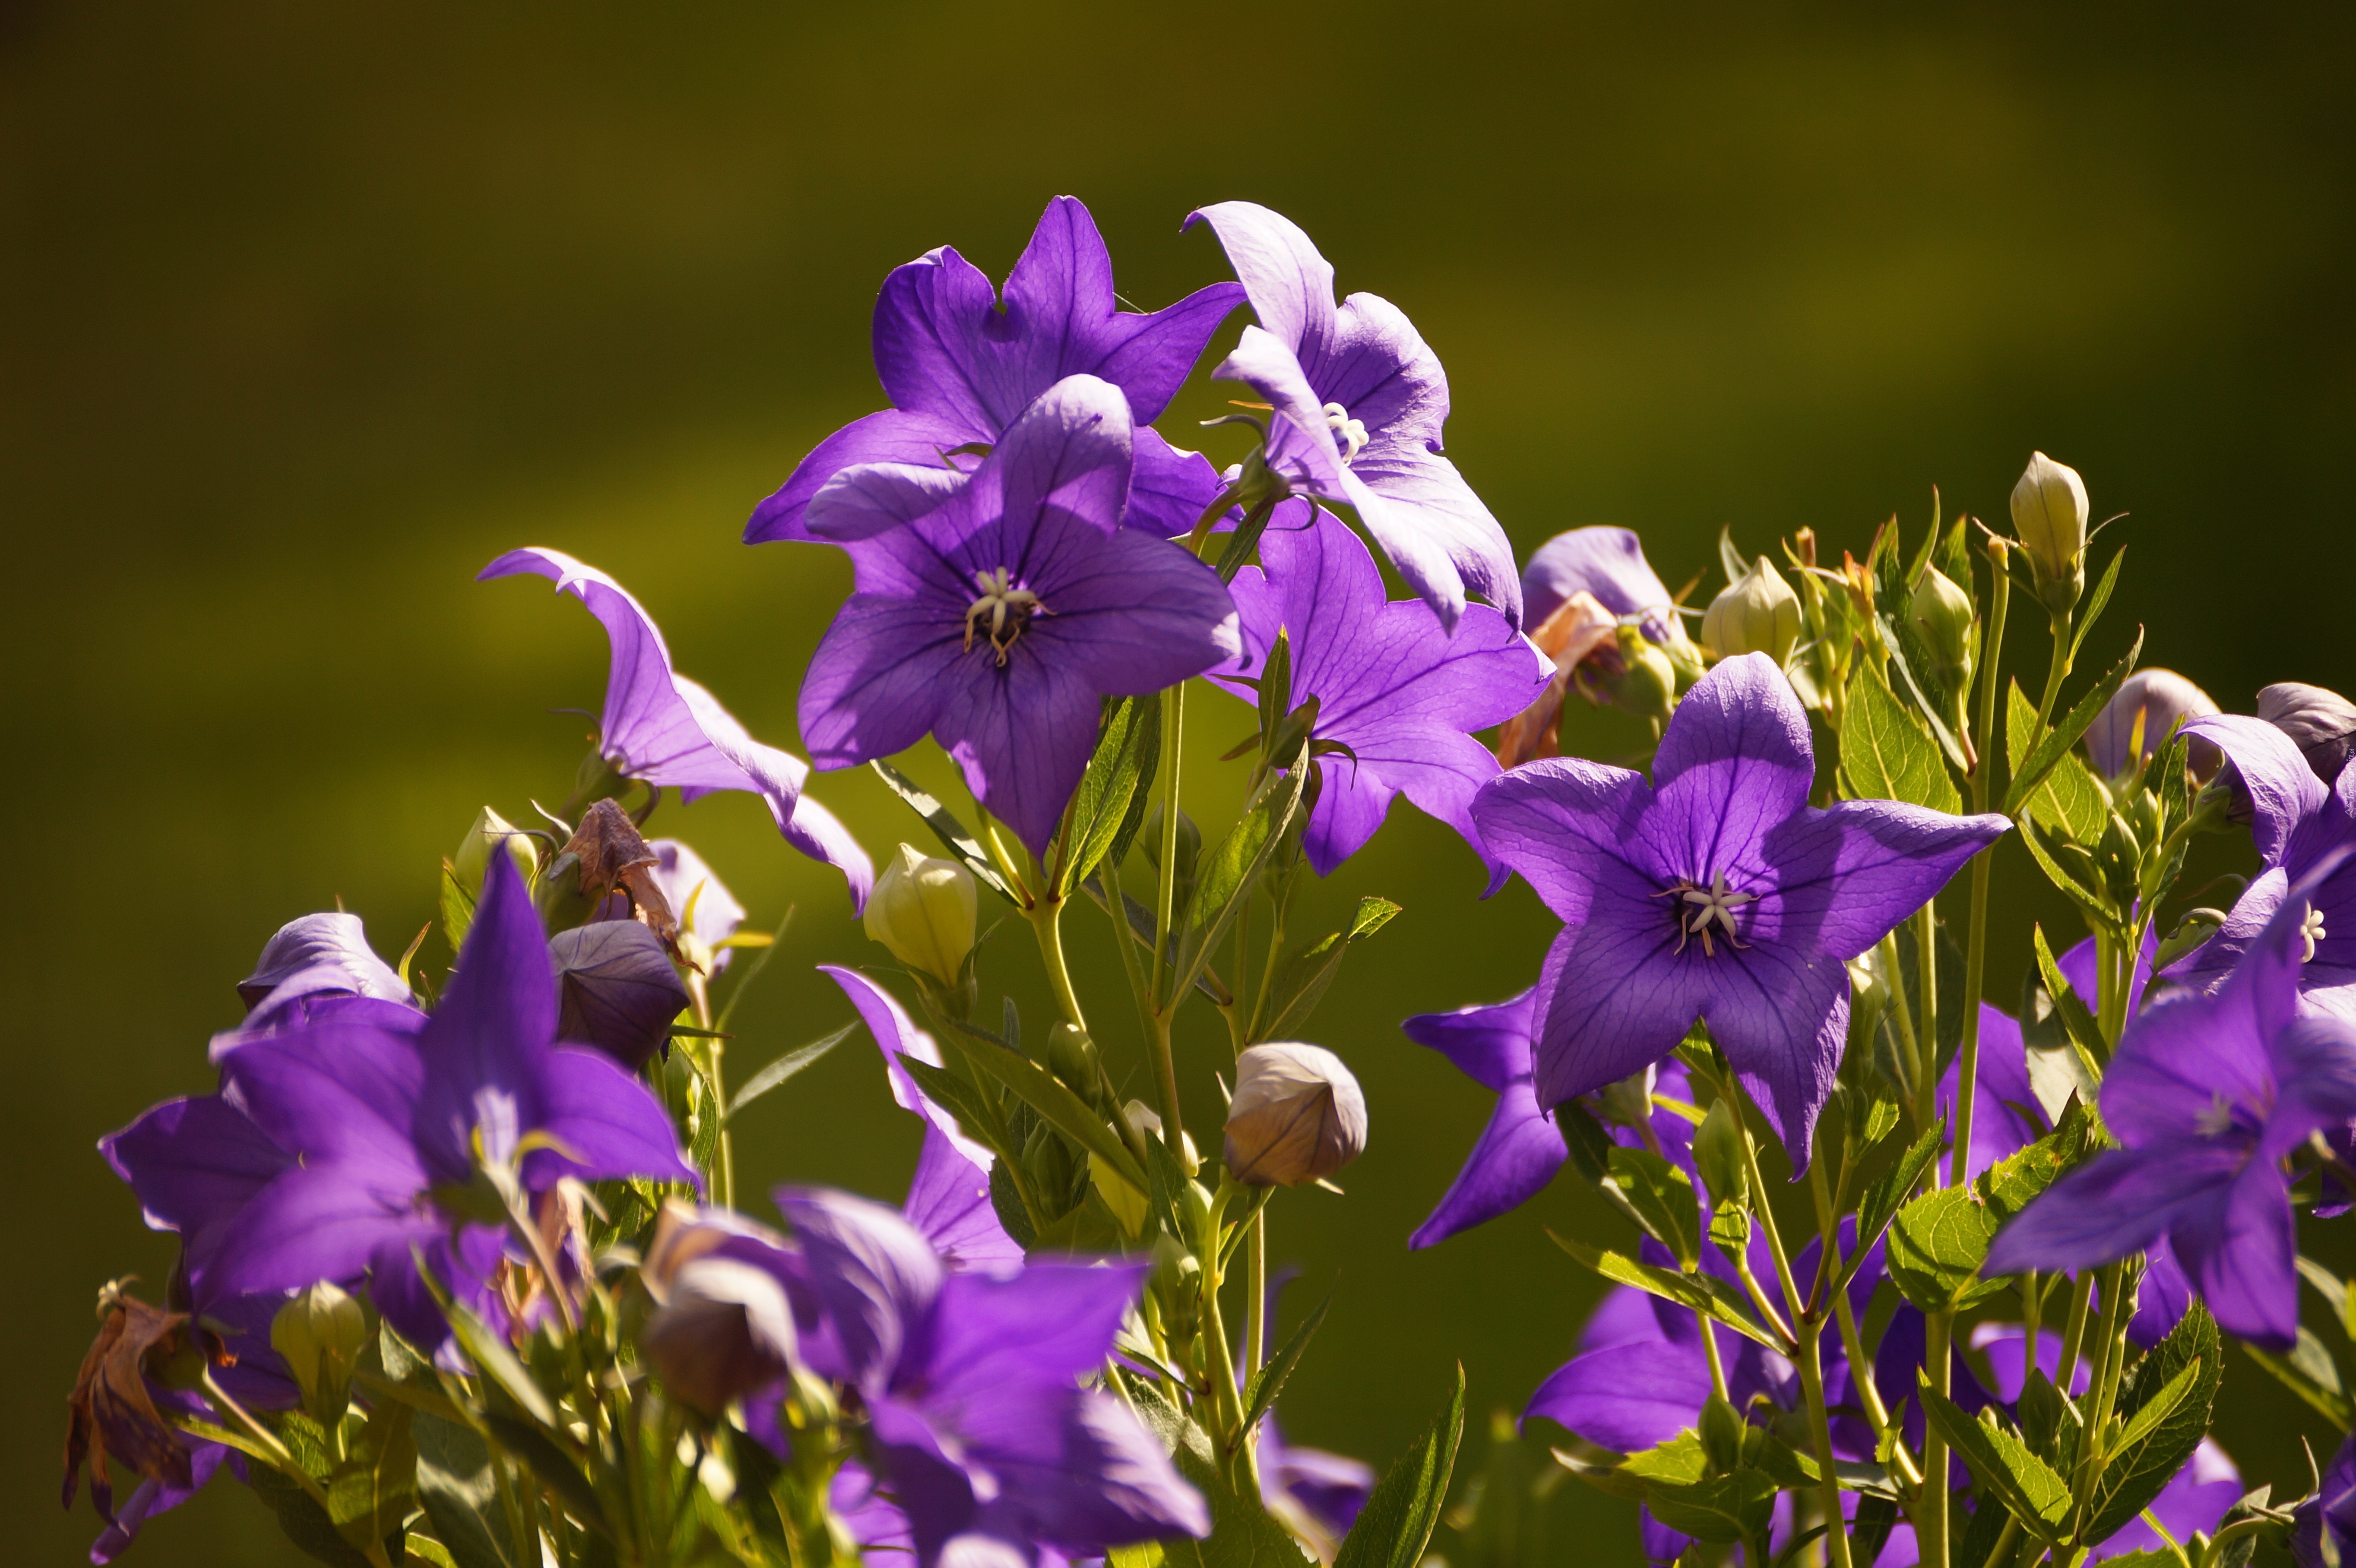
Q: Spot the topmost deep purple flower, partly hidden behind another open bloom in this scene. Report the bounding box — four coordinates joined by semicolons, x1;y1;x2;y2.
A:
744;196;1244;544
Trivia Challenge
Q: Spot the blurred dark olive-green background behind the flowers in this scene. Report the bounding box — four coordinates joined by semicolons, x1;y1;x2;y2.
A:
0;0;2356;1563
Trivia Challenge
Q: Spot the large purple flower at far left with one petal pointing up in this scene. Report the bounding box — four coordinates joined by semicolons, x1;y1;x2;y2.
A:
101;855;695;1347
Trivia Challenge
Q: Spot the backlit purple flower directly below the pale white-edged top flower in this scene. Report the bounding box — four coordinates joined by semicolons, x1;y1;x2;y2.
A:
1213;509;1553;892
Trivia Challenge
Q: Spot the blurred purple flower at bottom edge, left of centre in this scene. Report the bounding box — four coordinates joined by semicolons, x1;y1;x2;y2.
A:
777;1189;1211;1568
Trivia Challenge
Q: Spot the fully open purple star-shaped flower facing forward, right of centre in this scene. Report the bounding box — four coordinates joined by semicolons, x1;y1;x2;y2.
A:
1472;654;2010;1168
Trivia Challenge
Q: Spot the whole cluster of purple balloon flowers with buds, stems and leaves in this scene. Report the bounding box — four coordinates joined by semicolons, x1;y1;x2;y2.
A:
66;198;2356;1568
